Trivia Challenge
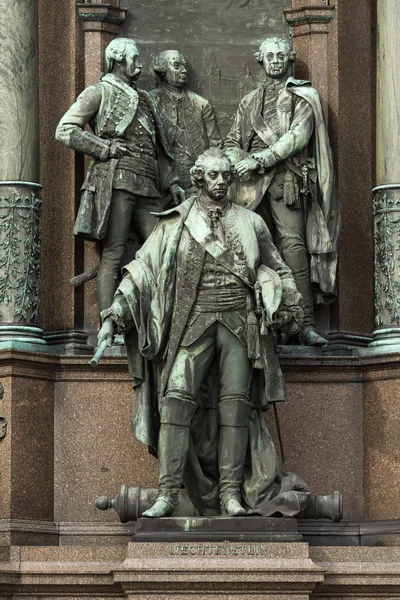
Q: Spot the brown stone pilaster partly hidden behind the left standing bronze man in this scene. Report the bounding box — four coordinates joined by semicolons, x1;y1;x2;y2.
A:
77;0;126;346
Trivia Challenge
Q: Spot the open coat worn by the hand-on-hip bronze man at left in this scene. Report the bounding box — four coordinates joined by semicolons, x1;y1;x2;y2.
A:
56;74;177;240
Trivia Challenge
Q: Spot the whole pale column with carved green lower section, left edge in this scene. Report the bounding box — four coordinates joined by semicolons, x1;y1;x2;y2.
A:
0;0;45;347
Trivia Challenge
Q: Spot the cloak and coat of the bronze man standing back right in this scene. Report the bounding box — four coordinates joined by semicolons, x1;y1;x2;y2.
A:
225;77;340;302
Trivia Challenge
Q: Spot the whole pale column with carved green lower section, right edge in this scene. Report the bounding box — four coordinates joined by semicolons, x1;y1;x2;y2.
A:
370;0;400;353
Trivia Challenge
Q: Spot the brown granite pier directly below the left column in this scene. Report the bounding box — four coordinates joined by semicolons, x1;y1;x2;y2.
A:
0;345;58;548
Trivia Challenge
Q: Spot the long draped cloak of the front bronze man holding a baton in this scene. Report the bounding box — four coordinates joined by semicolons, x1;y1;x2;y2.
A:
108;198;308;516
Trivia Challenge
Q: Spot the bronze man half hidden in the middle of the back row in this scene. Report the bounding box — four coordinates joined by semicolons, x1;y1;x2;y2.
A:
150;50;222;193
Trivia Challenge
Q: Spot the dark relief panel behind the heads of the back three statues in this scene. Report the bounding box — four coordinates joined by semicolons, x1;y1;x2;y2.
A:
120;0;290;136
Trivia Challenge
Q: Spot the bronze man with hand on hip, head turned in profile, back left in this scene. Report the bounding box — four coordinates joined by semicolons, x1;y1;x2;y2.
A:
56;38;184;310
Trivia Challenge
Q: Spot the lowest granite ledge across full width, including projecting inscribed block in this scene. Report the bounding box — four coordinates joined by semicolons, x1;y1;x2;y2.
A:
0;543;400;600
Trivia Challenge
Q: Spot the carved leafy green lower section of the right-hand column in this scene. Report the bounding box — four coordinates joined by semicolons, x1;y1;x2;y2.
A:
369;184;400;353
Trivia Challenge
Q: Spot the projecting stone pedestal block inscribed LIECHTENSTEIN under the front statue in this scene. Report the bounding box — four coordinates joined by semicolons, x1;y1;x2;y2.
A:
114;541;324;600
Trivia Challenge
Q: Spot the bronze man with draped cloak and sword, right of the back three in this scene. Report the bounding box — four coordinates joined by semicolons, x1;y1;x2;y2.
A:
225;37;339;345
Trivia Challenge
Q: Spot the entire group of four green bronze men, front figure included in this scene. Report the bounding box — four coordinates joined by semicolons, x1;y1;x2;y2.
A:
56;37;340;517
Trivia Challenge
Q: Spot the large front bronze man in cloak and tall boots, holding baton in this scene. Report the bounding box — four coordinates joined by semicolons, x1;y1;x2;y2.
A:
98;148;309;517
